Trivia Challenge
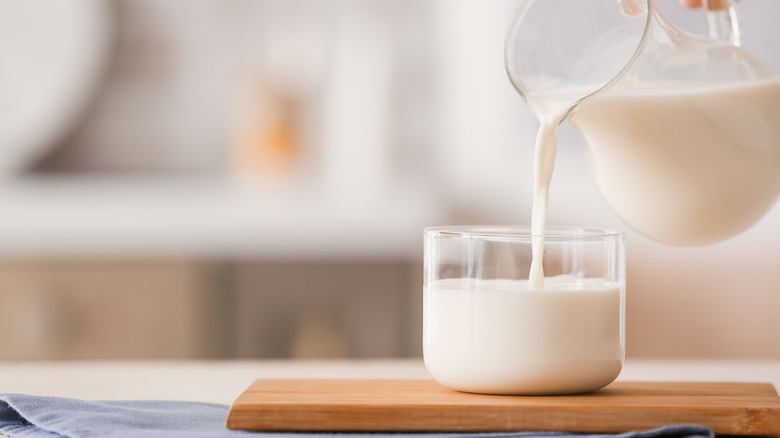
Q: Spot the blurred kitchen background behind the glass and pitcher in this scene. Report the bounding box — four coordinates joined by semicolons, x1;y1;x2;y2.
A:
0;0;780;359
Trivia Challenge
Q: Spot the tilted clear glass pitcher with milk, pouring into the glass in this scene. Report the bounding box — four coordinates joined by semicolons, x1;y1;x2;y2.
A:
506;0;780;246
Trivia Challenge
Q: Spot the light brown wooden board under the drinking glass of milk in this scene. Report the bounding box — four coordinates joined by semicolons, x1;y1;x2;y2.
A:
227;380;780;435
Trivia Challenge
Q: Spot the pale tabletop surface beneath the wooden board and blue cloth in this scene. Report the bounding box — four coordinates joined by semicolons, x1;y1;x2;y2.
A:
0;359;780;404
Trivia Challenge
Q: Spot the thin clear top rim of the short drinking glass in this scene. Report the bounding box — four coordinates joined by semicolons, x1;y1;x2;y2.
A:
423;225;626;240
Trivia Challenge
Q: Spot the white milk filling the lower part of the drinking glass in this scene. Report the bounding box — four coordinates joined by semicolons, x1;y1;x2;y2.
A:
423;276;625;394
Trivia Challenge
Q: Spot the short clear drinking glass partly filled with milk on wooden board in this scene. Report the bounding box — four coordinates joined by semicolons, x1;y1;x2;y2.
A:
423;226;626;395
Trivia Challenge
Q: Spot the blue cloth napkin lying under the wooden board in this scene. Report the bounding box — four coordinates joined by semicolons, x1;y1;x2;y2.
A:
0;394;714;438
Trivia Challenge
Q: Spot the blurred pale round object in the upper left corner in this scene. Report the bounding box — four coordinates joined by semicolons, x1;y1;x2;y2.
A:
0;0;111;175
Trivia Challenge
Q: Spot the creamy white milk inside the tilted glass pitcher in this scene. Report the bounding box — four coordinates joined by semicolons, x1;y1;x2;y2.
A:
568;79;780;245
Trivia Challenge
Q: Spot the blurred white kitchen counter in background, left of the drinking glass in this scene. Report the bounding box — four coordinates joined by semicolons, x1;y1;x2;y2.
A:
0;176;442;259
